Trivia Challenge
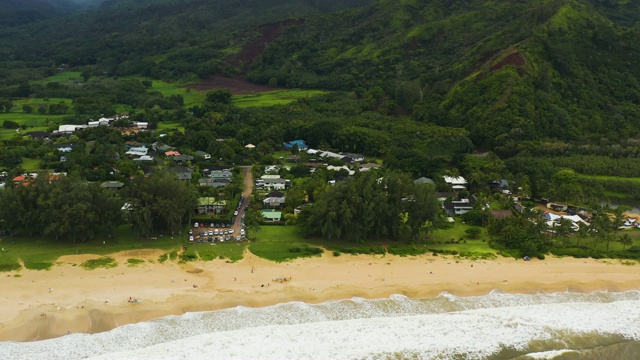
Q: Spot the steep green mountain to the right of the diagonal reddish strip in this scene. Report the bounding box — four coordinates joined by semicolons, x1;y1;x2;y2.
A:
244;0;640;148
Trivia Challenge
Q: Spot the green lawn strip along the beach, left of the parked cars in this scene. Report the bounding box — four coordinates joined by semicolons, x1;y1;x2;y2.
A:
0;225;180;270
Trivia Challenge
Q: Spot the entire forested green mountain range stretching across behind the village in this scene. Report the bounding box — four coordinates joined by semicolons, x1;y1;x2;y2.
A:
0;0;640;149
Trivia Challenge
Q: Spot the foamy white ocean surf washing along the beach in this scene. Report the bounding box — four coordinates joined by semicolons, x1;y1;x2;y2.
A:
0;291;640;360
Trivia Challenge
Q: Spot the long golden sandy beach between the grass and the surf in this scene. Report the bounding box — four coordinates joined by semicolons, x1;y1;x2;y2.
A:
0;250;640;341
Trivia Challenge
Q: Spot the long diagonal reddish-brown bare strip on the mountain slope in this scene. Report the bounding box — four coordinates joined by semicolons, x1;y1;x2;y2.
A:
227;20;304;72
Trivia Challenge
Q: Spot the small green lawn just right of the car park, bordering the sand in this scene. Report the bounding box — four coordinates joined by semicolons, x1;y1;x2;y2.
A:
249;226;317;262
